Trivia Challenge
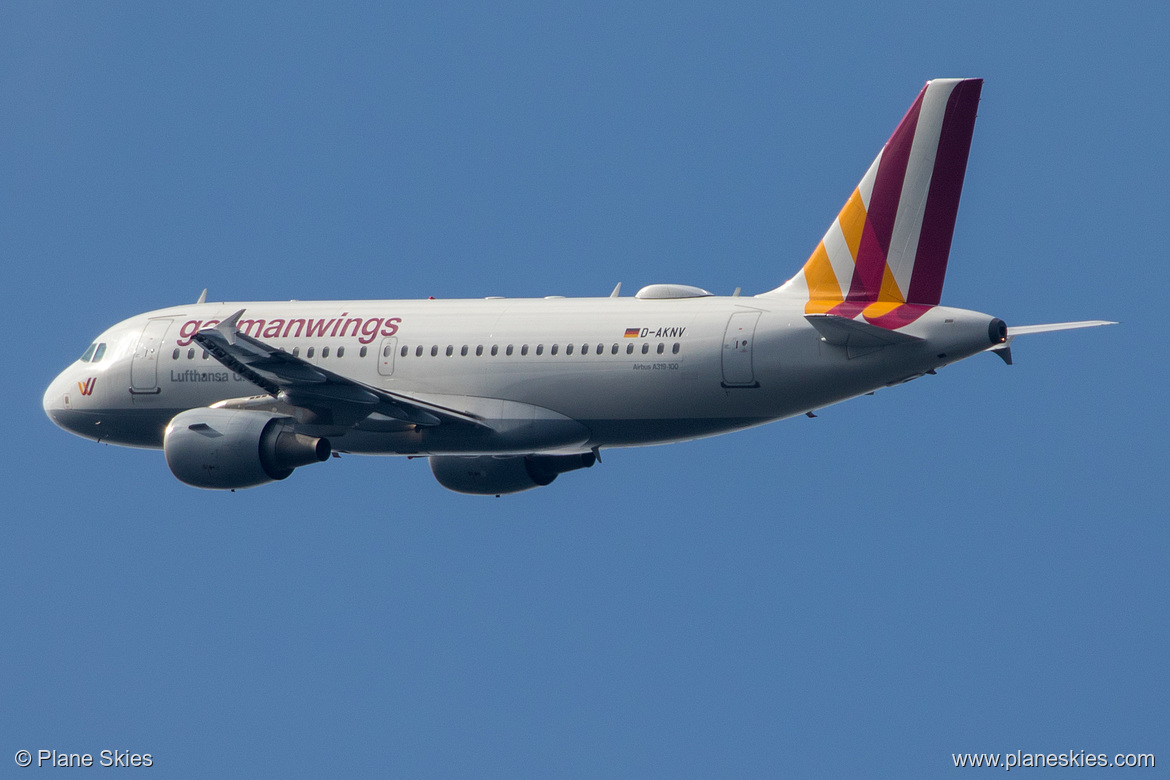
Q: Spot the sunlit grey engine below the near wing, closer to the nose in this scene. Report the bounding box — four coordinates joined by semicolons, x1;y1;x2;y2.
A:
163;409;332;490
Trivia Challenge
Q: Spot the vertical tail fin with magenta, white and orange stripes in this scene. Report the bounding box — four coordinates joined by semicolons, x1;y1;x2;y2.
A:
765;78;983;327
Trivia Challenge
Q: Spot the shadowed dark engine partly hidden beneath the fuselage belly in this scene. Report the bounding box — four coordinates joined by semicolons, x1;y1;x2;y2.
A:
431;453;597;496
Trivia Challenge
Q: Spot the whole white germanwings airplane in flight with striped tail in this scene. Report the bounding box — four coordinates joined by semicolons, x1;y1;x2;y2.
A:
43;78;1116;496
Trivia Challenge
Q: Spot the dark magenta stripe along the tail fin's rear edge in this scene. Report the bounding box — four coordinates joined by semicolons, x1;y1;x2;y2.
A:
906;78;983;305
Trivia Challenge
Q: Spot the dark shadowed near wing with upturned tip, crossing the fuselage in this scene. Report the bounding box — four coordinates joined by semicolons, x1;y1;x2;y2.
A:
192;309;488;428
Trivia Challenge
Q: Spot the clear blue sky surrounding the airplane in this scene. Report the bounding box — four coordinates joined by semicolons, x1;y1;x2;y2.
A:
0;2;1170;776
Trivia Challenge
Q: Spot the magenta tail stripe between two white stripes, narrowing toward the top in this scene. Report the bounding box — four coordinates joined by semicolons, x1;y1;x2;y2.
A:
848;87;927;301
